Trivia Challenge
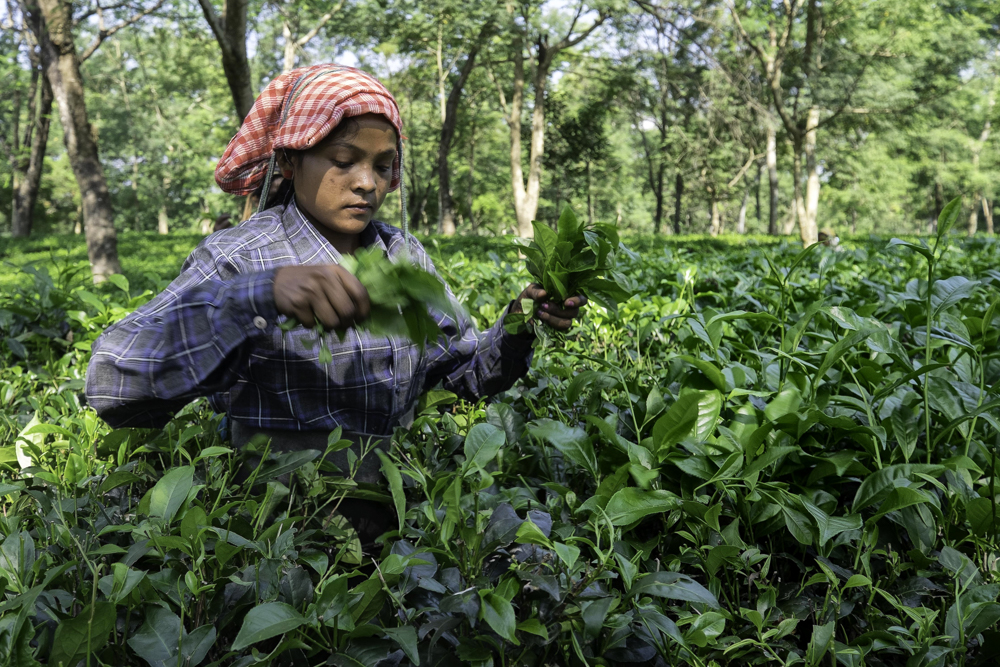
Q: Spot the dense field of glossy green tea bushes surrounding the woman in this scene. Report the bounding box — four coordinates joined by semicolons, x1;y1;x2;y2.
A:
0;211;1000;667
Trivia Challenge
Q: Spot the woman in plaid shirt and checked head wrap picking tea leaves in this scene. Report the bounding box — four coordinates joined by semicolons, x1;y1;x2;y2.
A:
87;65;586;538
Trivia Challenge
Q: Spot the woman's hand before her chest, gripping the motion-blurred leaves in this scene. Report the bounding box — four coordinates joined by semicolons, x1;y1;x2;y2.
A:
274;264;371;330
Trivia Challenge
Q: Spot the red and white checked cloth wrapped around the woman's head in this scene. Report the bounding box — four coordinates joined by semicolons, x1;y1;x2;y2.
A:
215;65;403;195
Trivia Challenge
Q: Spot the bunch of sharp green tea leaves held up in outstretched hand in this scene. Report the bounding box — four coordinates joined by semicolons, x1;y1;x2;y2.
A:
505;206;632;331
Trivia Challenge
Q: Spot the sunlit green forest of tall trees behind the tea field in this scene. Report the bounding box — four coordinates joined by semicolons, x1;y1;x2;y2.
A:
0;0;1000;273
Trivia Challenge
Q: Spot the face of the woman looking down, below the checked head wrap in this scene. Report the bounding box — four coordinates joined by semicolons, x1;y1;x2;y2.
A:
278;114;396;237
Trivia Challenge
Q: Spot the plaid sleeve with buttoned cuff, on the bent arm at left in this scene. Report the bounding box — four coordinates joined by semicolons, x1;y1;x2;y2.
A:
87;245;278;428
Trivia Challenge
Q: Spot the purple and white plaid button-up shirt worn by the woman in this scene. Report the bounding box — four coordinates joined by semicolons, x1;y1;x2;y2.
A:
87;201;532;435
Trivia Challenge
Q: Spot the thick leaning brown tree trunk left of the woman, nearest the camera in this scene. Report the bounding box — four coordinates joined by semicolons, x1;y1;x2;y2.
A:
22;0;121;283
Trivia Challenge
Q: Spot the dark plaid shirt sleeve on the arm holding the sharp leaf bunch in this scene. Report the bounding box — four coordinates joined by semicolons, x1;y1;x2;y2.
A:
412;241;535;401
